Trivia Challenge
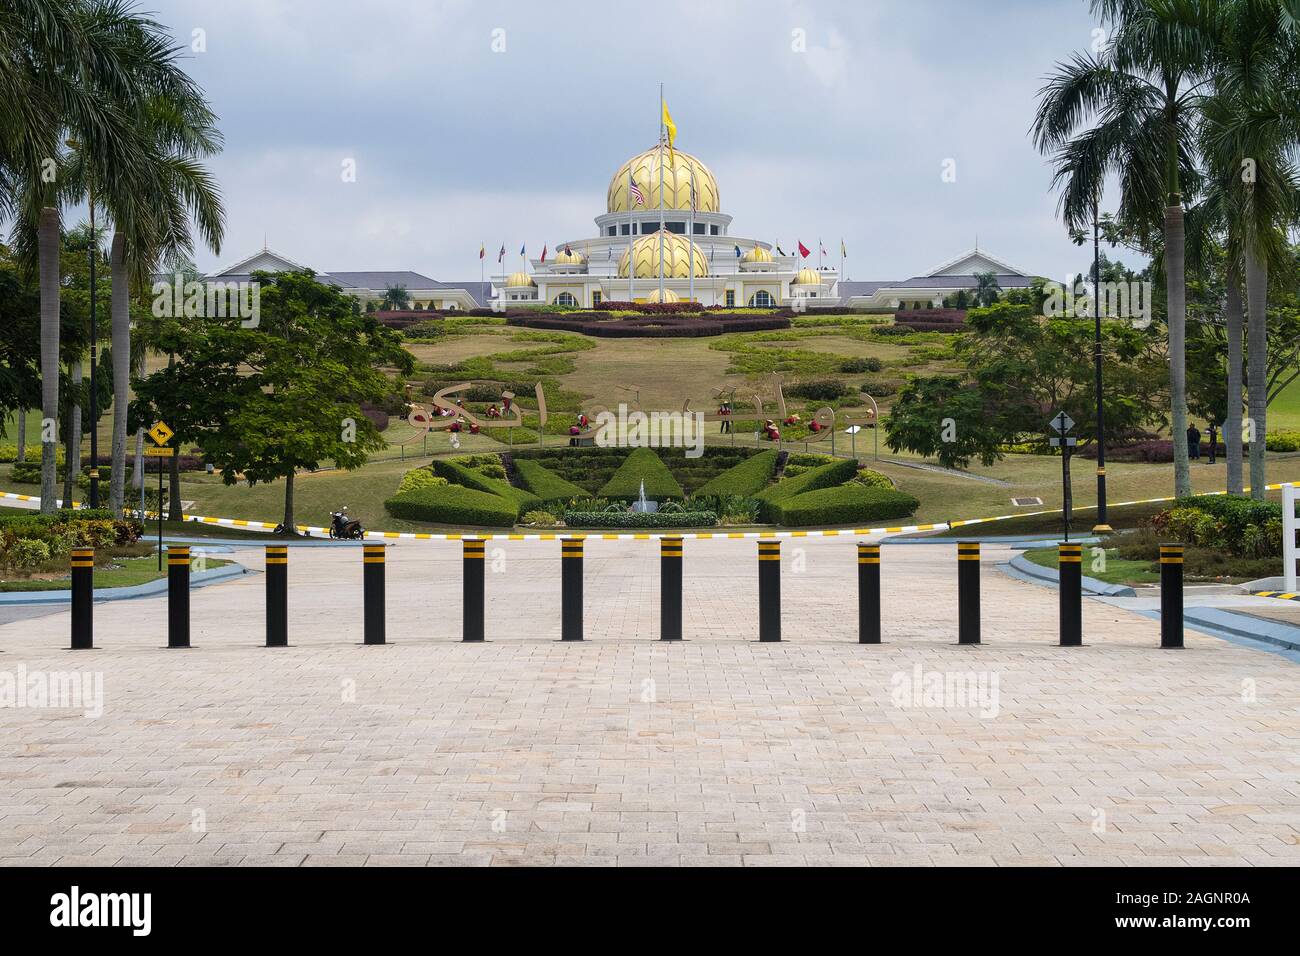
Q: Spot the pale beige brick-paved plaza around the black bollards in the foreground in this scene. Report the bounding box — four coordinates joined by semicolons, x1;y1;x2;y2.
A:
0;538;1300;866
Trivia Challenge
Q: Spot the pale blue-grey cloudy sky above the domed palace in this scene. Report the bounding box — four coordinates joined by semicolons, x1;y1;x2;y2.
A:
144;0;1138;280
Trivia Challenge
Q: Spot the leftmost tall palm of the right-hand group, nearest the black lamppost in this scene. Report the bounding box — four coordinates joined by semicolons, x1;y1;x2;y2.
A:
1032;0;1209;496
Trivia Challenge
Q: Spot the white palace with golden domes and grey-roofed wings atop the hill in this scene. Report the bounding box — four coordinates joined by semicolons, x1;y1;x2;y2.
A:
207;146;1032;310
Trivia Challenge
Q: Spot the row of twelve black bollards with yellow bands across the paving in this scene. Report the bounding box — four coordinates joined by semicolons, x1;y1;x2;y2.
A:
70;536;1183;650
